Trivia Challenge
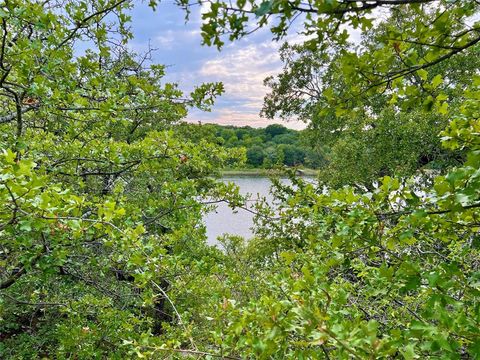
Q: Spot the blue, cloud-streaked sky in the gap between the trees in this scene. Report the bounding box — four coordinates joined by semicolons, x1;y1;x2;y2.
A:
127;0;305;129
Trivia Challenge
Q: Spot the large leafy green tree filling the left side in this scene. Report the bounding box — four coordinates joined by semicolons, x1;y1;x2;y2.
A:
0;0;238;359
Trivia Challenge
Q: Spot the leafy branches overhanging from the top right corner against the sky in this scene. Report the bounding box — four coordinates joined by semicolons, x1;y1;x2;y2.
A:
177;0;480;109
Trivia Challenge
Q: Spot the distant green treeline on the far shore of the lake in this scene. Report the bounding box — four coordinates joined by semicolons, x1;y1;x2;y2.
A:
174;123;323;169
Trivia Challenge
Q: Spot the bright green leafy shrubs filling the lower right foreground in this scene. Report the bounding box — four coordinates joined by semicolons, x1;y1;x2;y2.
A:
161;76;480;359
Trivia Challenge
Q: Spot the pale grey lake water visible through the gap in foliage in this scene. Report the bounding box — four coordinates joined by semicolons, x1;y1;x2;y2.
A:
204;176;314;245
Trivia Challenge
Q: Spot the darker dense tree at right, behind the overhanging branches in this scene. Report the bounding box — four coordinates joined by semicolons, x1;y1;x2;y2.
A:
262;37;479;186
